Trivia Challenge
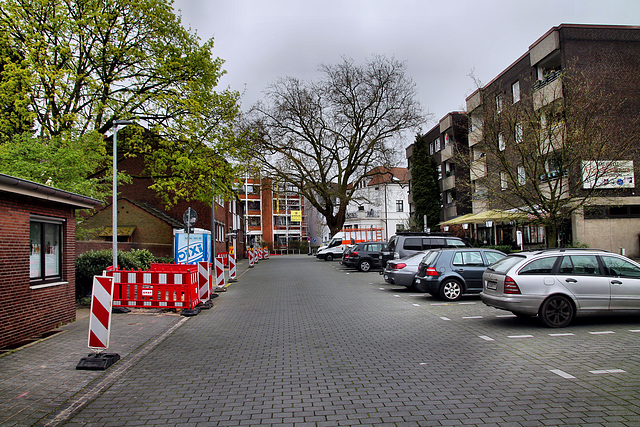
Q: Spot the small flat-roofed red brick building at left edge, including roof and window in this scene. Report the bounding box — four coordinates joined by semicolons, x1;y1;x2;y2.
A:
0;174;101;348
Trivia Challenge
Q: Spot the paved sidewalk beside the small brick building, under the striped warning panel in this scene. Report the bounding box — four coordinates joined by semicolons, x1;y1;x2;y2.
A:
0;260;248;426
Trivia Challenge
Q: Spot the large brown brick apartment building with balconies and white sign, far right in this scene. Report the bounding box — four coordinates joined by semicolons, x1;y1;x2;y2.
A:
466;24;640;256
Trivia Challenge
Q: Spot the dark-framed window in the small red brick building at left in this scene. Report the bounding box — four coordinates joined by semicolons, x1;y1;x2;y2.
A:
29;217;63;283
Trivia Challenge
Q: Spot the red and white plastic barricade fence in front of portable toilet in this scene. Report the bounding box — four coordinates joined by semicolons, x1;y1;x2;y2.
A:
107;266;200;310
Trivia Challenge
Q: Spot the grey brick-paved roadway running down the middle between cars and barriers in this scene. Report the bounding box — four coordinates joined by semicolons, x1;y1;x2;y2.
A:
0;256;640;426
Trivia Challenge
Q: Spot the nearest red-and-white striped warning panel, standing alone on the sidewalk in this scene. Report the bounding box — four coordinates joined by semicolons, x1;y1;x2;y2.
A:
88;276;113;351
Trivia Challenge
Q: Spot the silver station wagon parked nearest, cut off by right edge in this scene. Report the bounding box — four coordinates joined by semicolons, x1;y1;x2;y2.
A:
480;249;640;328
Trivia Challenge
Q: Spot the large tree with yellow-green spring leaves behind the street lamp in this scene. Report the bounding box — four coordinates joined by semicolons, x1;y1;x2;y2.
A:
0;0;245;206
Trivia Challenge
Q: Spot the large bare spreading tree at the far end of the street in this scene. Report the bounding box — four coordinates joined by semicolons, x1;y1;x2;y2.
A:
251;56;424;233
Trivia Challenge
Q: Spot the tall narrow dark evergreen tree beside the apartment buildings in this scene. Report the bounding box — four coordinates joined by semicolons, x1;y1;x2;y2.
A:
410;135;442;231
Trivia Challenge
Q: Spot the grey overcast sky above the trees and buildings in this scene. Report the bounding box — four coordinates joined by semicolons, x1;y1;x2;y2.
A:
174;0;640;132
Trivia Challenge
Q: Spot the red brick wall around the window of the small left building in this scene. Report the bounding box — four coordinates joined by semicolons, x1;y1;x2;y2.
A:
0;193;76;347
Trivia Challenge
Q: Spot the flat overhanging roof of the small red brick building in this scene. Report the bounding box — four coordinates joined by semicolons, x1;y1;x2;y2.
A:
0;174;102;209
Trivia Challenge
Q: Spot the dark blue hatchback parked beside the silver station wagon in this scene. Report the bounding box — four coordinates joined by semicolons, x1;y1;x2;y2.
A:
414;248;506;301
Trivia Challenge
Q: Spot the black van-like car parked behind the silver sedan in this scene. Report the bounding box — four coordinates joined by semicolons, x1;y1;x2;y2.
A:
382;232;471;264
